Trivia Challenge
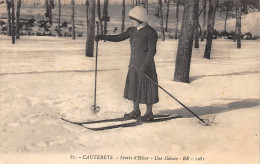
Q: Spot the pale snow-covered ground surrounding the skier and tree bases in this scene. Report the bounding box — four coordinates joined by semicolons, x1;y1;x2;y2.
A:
0;36;260;163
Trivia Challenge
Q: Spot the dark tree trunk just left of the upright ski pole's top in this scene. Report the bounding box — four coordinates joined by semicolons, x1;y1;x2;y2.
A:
86;0;96;57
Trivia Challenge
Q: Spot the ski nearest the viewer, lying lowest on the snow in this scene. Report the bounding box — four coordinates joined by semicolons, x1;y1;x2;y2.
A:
70;116;182;131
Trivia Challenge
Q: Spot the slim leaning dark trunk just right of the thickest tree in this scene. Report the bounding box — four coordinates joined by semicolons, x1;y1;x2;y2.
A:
204;0;217;59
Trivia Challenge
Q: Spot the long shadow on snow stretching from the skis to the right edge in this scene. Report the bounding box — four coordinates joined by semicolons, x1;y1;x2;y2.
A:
158;99;260;118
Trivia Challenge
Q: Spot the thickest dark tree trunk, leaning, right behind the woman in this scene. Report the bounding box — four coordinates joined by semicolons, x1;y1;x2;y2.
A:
174;0;199;83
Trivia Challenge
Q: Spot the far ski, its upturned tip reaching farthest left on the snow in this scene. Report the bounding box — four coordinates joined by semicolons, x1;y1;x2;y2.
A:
61;115;170;125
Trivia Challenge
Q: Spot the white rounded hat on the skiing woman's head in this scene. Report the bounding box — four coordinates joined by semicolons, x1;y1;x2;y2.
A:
129;6;148;23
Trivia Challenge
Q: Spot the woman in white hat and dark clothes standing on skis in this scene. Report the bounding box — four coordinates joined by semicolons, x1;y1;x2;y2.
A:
95;6;159;121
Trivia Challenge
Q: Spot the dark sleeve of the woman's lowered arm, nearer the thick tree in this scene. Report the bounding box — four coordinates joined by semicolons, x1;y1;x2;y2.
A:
140;31;158;72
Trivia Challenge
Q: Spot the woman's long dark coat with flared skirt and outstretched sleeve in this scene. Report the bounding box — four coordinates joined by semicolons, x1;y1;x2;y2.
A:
105;25;159;104
